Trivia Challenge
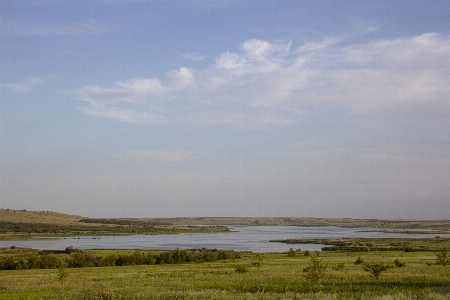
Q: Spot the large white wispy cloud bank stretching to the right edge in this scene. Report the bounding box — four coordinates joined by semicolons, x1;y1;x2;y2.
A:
77;33;450;127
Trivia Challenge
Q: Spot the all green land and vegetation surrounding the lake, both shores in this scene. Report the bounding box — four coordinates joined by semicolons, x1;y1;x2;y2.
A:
0;209;450;300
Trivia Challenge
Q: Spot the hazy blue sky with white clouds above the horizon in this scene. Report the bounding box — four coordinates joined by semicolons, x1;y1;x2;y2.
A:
0;0;450;219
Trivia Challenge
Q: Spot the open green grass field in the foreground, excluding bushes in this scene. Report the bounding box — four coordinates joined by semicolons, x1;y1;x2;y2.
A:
0;251;450;300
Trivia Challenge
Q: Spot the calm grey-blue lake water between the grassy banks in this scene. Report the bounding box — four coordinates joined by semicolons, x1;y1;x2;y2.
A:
0;226;444;252
